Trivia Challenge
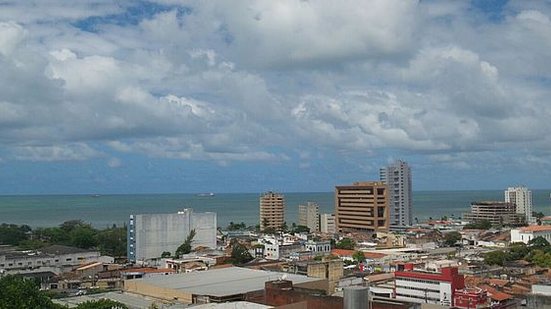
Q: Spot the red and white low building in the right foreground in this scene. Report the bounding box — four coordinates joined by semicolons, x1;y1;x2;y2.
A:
394;263;465;306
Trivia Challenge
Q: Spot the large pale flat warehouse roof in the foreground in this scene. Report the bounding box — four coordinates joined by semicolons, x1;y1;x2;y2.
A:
131;267;323;297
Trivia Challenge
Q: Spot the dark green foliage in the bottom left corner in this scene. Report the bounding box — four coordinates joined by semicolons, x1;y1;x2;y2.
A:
0;275;63;309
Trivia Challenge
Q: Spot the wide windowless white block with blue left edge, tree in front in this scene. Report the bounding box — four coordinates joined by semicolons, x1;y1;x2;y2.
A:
128;209;216;262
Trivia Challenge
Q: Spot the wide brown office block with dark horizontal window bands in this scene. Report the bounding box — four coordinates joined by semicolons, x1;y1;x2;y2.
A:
335;182;389;232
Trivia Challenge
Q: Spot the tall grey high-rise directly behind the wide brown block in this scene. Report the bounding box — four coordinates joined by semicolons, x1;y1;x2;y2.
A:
380;160;413;227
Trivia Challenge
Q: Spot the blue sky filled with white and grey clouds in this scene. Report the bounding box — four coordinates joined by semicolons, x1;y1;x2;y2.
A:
0;0;551;194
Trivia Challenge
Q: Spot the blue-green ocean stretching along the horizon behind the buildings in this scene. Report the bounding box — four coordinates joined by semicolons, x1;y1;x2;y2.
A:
0;190;551;228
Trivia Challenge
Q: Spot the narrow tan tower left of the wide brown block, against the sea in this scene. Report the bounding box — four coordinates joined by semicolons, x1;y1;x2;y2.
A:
260;191;285;230
